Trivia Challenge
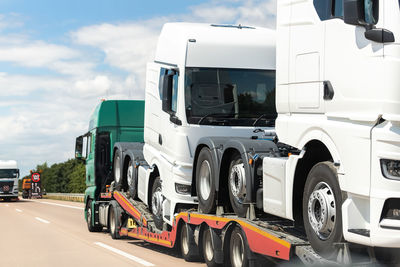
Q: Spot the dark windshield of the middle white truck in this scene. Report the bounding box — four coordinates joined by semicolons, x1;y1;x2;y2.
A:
185;68;276;126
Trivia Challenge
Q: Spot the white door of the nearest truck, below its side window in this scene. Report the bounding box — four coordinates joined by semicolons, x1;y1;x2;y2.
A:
319;0;384;117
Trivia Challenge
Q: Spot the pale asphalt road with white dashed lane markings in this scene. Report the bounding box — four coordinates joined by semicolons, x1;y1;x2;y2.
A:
0;199;205;267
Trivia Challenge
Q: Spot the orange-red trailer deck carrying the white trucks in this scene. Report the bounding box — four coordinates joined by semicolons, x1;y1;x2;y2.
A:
112;191;335;265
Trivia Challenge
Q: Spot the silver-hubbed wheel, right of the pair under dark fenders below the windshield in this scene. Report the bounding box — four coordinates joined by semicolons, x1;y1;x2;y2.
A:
228;154;248;217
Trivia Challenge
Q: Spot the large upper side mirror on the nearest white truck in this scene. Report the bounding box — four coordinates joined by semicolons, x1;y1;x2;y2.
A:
343;0;379;28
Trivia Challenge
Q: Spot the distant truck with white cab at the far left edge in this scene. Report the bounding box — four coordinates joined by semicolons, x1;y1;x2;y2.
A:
0;160;19;201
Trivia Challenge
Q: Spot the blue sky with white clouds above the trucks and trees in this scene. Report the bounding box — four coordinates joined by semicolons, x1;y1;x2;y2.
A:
0;0;276;178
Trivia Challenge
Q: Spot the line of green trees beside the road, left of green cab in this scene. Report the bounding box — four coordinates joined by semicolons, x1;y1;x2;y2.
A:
19;159;86;193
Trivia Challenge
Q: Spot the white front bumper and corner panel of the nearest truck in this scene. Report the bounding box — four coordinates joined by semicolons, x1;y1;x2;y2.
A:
342;122;400;248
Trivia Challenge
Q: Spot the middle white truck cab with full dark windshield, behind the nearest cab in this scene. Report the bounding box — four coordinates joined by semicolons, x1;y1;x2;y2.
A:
138;23;276;227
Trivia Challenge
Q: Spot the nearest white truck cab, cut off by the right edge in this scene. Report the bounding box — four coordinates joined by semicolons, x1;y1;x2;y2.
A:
274;0;400;258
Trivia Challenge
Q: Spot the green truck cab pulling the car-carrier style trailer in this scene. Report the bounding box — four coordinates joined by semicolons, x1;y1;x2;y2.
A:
75;100;144;231
